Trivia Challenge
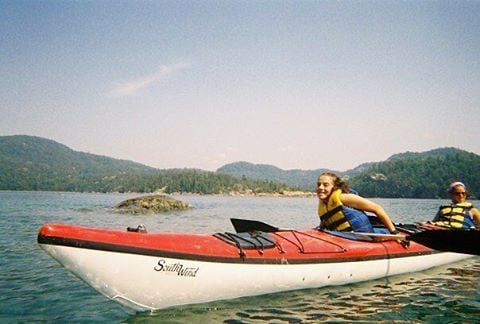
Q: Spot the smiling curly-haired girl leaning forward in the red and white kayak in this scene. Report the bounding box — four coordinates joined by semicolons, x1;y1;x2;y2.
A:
317;172;398;234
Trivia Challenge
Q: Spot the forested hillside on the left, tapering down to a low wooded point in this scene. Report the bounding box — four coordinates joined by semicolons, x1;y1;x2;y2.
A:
0;135;289;194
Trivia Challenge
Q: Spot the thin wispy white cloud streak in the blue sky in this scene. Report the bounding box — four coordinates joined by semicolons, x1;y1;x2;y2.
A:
110;63;189;97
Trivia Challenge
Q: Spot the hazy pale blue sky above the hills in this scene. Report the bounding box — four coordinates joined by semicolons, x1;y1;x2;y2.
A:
0;0;480;171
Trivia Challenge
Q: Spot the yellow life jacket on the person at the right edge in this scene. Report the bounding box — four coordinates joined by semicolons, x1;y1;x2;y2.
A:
433;202;475;228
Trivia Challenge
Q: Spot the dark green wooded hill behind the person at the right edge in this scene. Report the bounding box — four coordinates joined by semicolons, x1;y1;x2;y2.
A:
349;148;480;198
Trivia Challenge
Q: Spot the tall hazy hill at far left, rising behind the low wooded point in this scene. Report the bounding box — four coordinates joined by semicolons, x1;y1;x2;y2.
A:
0;135;155;191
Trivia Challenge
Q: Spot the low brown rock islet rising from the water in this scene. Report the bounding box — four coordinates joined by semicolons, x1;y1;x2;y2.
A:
114;195;192;214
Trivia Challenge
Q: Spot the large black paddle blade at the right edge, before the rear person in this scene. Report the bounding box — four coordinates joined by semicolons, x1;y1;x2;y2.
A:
407;230;480;255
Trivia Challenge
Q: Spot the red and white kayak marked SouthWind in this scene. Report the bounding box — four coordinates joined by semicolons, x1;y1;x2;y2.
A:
37;220;472;311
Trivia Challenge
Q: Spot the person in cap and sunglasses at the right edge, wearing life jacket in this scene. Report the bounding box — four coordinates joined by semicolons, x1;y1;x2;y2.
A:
433;181;480;228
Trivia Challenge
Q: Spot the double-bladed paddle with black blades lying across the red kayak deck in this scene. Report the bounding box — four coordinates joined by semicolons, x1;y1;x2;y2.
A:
230;218;480;255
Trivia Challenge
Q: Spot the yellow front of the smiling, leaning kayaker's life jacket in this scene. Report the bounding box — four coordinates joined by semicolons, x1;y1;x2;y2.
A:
318;189;352;231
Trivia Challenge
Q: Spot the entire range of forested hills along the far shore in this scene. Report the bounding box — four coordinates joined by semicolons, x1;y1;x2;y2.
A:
0;135;480;198
